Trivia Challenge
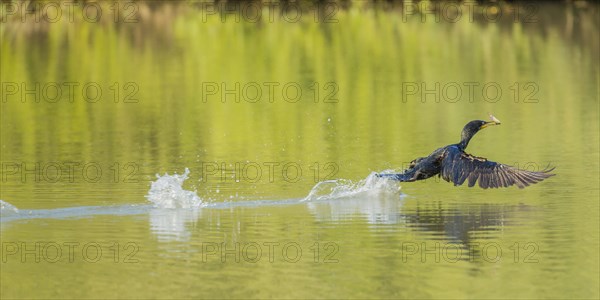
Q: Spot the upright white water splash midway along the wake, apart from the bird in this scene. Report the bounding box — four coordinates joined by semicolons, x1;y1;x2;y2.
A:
146;168;202;208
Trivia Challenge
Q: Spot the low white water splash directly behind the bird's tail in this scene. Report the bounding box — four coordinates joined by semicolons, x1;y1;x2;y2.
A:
302;172;400;201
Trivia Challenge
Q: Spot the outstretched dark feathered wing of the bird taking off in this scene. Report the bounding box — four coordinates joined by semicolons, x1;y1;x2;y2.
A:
440;147;555;189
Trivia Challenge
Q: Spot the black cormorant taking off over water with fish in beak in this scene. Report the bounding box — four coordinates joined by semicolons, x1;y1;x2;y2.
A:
377;115;555;189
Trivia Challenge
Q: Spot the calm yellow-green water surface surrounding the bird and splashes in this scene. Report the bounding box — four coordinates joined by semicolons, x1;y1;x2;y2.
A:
0;3;600;298
